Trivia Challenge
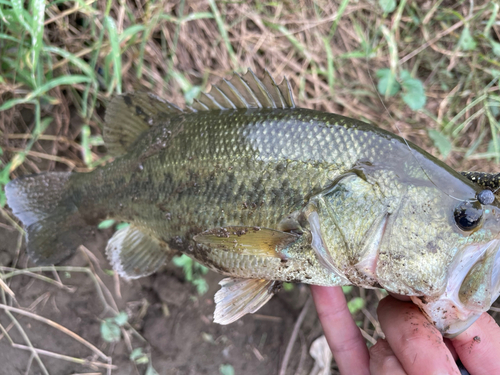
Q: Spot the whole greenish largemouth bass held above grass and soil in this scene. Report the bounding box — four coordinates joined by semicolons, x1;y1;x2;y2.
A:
5;70;500;337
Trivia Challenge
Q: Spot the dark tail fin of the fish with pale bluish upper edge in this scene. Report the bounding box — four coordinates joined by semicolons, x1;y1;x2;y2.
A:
5;172;90;265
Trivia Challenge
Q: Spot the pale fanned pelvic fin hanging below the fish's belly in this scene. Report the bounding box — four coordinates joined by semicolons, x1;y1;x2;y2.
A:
214;277;282;325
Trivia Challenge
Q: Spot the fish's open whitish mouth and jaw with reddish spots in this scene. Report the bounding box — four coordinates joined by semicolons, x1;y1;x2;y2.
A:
411;239;500;338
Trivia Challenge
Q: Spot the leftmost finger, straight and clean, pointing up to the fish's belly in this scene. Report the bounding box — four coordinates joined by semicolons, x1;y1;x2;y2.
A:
311;285;370;375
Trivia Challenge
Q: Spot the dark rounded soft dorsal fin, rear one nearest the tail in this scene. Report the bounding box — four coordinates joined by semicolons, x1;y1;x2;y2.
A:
103;91;183;156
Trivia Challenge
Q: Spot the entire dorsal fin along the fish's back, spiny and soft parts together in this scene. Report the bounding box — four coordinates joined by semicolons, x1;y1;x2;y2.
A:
103;69;295;156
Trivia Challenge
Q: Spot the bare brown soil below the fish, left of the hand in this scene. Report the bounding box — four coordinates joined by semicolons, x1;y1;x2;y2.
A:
0;223;328;375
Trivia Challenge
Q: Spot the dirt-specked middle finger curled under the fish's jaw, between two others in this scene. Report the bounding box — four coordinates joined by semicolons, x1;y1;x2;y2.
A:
377;296;459;375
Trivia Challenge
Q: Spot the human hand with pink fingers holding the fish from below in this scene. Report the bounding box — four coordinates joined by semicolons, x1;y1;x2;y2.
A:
311;286;500;375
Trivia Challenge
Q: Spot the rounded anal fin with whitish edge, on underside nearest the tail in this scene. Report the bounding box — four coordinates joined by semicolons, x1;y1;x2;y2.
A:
106;225;175;279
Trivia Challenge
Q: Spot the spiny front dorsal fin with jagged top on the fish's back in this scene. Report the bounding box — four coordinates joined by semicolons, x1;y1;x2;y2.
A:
192;69;295;111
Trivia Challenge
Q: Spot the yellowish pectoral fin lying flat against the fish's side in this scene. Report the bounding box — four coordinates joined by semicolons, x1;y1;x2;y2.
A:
194;226;300;257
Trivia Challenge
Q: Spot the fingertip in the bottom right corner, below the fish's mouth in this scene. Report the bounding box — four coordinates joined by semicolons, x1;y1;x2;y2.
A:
451;313;500;375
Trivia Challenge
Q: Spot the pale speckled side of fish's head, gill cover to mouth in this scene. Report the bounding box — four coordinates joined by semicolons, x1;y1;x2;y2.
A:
308;169;500;336
